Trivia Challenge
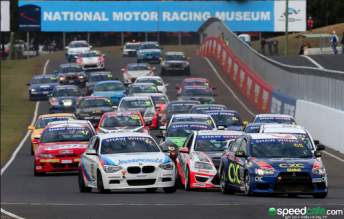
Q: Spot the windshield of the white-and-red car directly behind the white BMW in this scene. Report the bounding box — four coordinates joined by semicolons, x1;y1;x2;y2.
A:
100;114;142;127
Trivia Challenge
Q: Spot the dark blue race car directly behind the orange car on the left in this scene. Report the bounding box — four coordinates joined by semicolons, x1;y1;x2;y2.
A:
49;85;82;114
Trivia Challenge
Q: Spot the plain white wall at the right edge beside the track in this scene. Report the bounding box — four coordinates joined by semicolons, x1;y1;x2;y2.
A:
295;100;344;153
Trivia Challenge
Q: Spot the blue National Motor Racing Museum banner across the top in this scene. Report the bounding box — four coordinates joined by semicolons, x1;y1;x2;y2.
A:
18;0;307;32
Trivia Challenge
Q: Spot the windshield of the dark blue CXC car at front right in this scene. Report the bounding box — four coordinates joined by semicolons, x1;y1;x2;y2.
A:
251;139;313;158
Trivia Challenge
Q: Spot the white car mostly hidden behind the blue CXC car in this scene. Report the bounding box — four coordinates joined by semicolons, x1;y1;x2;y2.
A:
259;124;325;159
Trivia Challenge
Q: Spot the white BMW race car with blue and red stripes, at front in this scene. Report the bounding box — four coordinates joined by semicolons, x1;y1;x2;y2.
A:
78;132;177;193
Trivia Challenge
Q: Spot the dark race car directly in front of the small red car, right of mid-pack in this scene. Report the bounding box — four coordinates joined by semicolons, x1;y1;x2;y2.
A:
177;86;217;104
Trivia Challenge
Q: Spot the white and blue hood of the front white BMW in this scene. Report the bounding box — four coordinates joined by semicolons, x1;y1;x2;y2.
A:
99;152;171;165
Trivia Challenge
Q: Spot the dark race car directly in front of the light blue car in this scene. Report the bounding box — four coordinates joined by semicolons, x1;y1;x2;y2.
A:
75;96;114;126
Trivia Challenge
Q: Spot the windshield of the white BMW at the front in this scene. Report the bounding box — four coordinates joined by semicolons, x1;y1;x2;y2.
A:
100;137;160;154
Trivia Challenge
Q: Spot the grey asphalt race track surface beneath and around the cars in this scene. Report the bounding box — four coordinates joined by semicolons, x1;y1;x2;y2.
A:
1;57;344;219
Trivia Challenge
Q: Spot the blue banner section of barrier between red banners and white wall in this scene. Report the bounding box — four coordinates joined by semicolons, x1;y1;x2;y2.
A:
270;90;297;118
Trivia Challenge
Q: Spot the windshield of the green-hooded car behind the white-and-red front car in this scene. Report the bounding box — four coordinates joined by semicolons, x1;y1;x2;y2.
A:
166;124;212;137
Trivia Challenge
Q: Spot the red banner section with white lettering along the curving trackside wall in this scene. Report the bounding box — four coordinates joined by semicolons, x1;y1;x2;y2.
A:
197;37;273;113
